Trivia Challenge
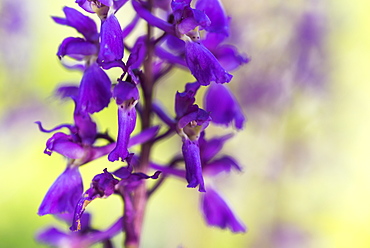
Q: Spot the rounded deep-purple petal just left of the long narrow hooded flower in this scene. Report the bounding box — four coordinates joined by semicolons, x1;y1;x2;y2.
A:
78;63;111;114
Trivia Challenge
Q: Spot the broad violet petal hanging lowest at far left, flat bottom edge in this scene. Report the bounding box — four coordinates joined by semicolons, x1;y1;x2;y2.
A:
38;167;83;215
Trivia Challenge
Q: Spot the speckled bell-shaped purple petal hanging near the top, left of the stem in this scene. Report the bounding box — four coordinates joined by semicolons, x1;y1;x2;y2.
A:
98;14;123;63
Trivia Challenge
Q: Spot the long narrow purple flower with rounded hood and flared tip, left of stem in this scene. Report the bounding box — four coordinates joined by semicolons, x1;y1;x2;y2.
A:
108;81;139;162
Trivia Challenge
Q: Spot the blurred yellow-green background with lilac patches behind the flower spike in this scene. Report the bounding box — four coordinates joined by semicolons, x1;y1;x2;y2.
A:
0;0;370;248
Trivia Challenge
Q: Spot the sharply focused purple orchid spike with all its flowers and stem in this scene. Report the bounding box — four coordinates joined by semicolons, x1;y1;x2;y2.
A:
37;0;249;247
